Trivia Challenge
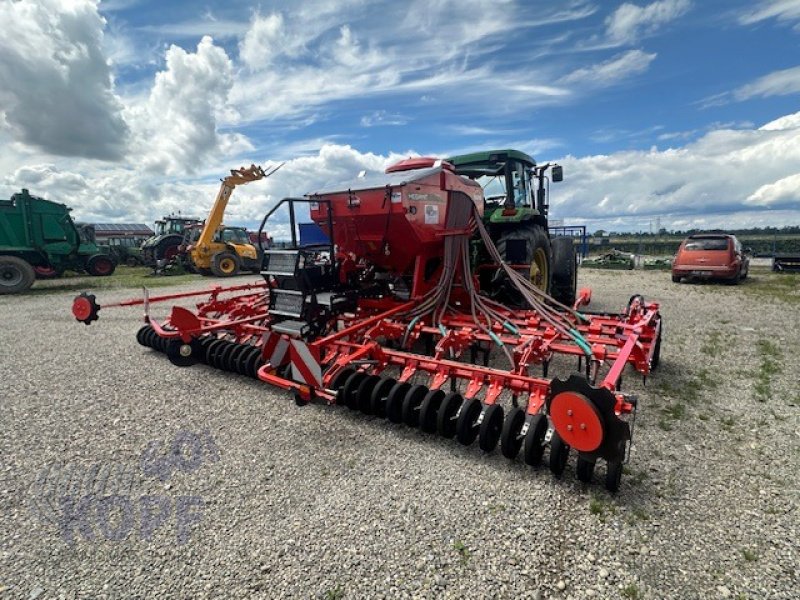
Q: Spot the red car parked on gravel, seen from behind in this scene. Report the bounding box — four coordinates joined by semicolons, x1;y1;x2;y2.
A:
672;233;750;283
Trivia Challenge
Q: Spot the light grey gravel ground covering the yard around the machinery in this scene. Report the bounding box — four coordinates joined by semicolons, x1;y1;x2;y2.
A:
0;270;800;599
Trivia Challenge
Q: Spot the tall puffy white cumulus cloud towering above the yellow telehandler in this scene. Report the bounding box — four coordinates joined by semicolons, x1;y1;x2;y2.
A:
127;37;252;174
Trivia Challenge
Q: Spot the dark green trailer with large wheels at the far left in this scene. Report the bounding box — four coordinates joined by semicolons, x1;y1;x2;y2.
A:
0;189;116;294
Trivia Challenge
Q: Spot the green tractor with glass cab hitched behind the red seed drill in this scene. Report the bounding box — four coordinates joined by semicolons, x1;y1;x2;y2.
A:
445;150;578;305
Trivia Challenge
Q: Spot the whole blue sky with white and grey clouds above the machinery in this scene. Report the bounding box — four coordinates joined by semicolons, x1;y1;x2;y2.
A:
0;0;800;230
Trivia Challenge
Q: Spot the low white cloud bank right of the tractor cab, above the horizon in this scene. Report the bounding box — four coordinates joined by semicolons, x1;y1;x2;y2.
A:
552;113;800;226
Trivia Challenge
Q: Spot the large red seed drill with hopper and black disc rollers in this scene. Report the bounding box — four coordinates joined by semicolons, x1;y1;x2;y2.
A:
73;154;661;492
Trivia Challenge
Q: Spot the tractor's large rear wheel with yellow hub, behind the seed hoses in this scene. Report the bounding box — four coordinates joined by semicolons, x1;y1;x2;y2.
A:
495;221;552;298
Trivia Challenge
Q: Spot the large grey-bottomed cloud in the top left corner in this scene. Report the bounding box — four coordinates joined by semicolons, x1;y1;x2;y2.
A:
0;0;128;160
